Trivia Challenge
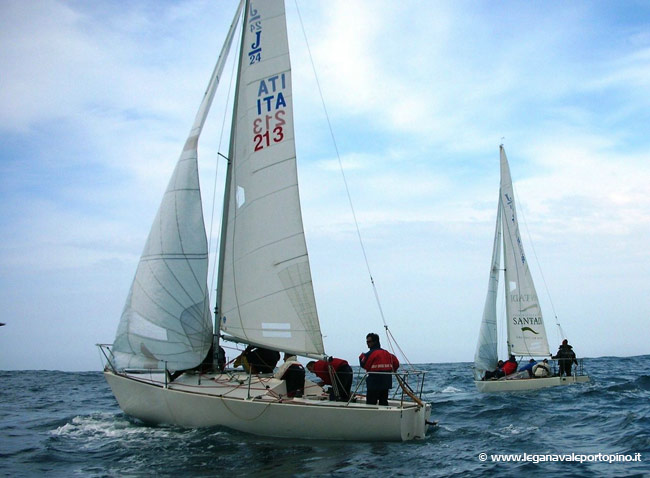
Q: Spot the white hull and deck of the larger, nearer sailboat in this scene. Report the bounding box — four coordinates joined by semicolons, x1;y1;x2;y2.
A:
104;371;431;441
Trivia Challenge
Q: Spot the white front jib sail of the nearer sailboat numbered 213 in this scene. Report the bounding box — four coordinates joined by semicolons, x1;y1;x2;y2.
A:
113;3;242;370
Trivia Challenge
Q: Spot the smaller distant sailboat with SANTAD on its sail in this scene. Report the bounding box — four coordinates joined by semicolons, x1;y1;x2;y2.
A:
474;145;589;392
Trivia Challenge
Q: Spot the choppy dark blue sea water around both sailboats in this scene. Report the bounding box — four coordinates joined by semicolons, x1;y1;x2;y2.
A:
0;356;650;477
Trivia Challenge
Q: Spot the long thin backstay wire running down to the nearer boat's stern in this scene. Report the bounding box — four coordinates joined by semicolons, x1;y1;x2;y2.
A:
294;0;411;365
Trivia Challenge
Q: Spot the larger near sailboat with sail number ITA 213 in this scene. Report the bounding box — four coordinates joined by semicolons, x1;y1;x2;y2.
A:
100;0;431;441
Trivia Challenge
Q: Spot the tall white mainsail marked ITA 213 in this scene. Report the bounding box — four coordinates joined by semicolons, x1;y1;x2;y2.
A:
218;0;324;355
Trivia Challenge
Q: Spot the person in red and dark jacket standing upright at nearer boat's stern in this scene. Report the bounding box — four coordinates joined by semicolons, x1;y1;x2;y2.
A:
359;333;399;405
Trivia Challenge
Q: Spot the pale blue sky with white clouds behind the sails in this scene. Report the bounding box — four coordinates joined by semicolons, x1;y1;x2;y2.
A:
0;0;650;373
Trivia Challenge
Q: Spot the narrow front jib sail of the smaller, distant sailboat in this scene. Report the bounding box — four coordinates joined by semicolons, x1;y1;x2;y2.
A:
474;200;502;379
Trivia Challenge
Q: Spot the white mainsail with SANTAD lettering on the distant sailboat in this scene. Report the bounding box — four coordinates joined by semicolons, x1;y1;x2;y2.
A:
500;146;549;356
